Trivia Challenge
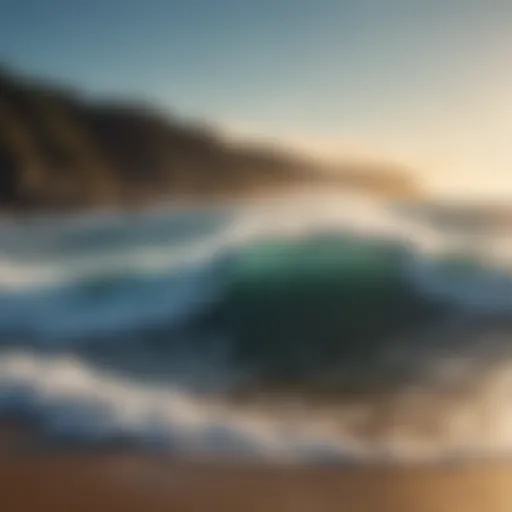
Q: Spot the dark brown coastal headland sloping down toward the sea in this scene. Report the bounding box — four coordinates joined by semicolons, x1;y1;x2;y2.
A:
0;68;418;211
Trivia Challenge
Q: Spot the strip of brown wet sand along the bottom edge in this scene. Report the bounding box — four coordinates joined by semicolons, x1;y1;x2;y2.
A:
0;422;512;512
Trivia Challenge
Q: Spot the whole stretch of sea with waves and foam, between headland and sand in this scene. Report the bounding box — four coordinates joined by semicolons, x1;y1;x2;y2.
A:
0;193;512;463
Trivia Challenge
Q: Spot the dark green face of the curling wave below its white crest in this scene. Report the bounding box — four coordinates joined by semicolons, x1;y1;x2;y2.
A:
220;237;448;388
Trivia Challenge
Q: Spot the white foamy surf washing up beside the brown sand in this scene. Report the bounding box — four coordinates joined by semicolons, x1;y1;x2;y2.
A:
0;340;512;463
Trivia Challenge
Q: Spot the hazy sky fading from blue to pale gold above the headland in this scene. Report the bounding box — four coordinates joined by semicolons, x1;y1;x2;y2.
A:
0;0;512;198
